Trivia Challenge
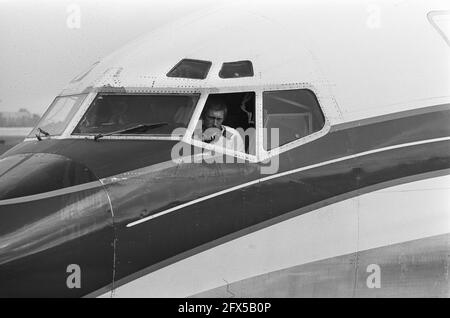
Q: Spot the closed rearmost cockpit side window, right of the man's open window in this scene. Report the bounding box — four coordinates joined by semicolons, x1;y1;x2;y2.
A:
263;89;325;150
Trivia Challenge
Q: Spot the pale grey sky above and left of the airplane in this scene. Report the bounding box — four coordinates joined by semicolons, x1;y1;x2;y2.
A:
0;0;223;115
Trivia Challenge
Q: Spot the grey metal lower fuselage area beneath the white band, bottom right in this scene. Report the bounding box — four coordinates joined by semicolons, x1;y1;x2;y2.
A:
191;234;450;298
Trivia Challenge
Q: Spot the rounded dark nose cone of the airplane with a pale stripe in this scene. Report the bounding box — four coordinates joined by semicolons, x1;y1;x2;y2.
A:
0;153;114;298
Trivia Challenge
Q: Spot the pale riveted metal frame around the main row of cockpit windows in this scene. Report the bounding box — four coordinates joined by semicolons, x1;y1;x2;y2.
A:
26;83;331;163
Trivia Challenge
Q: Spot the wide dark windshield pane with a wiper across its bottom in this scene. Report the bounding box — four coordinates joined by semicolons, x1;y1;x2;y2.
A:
73;94;199;135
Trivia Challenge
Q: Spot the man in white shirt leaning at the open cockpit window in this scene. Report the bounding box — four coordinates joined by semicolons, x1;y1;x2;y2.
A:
202;97;245;152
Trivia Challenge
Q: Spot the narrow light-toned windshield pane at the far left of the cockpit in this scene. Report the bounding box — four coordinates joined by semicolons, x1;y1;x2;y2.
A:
29;94;87;136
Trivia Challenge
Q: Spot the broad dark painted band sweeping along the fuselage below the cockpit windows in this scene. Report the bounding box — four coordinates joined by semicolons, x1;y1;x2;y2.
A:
0;105;450;296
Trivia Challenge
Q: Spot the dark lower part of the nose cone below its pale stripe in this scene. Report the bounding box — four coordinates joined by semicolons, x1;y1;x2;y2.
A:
0;185;114;297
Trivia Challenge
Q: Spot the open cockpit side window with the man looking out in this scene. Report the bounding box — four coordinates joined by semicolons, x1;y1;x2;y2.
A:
193;92;256;155
